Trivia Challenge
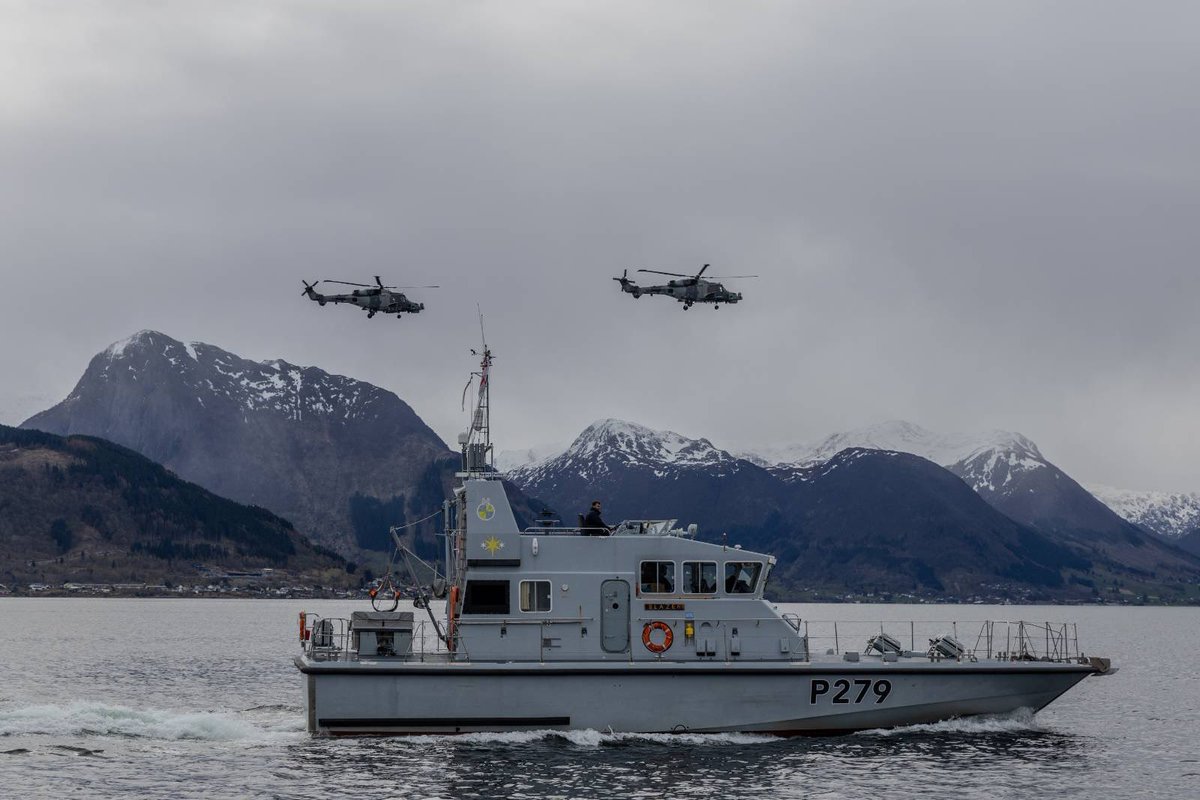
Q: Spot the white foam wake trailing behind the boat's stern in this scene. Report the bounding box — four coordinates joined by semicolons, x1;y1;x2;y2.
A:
0;703;305;741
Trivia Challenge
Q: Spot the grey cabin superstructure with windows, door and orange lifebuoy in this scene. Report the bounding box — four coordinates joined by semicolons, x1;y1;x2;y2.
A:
445;477;806;661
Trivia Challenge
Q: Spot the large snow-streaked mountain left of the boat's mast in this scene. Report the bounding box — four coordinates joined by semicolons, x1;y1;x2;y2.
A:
23;331;454;552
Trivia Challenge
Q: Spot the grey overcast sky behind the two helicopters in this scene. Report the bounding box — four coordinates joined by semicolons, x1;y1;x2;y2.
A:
0;0;1200;491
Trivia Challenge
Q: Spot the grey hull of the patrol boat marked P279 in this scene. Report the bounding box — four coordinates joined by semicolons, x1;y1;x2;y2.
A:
296;656;1096;735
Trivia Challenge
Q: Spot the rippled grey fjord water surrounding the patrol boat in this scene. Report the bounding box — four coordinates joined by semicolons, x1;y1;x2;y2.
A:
0;599;1200;800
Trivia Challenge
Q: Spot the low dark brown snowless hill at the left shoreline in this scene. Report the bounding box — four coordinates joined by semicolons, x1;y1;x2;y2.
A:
0;426;358;587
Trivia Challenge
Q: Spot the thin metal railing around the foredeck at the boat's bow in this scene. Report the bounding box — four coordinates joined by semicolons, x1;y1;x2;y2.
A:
803;619;1085;662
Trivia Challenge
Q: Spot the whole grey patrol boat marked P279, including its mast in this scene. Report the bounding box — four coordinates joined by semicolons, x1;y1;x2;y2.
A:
295;347;1115;735
